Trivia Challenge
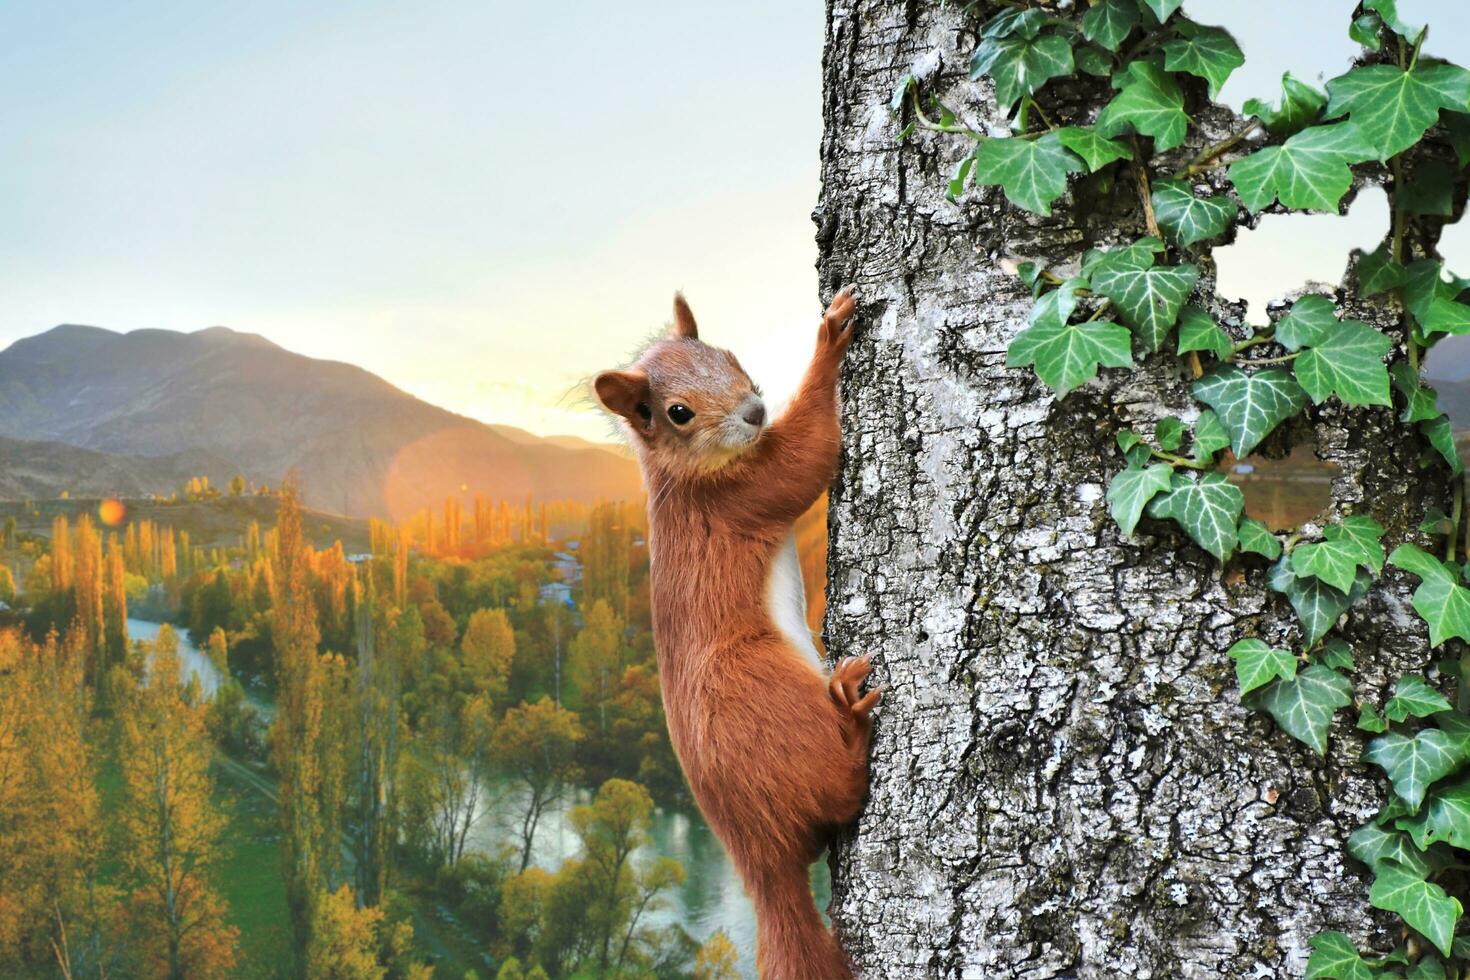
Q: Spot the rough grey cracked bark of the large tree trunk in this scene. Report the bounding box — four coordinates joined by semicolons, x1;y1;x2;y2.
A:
814;0;1446;977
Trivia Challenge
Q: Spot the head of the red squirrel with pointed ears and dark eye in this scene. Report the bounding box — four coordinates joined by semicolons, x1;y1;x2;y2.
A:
592;294;766;476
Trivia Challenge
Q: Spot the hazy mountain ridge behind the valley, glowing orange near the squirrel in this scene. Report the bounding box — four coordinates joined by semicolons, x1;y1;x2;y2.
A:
0;325;639;517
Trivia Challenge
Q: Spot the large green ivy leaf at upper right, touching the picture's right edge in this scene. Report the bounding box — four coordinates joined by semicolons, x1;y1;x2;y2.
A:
1327;62;1470;160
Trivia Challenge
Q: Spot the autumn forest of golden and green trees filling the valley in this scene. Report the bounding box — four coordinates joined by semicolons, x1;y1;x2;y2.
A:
0;483;782;980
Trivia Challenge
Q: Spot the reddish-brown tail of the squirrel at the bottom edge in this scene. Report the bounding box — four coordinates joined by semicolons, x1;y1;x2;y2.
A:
753;865;853;980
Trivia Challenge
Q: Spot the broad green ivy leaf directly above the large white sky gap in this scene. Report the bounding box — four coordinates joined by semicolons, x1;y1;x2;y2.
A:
1230;122;1373;213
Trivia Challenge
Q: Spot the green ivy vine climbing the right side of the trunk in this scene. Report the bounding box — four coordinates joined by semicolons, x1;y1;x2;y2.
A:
891;0;1470;980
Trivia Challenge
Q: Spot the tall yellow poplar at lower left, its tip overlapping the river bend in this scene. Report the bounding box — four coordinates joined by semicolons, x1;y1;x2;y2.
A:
115;626;238;980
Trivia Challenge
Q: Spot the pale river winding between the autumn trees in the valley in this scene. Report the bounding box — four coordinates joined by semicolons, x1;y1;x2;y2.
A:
128;619;831;977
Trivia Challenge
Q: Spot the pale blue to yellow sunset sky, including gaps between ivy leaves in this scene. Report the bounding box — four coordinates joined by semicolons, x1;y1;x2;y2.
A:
0;0;1470;438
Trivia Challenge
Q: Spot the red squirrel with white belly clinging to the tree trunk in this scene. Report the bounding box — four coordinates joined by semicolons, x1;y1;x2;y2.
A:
594;291;879;980
